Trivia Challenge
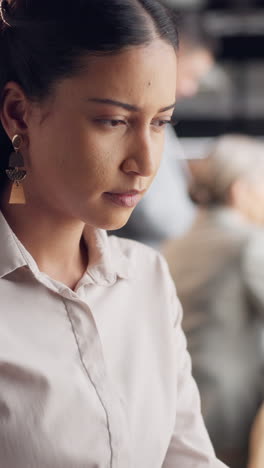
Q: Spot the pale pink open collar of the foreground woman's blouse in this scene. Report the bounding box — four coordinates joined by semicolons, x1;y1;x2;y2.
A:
0;211;130;286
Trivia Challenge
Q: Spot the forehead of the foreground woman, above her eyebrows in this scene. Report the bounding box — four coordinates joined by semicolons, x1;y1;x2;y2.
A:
54;39;176;108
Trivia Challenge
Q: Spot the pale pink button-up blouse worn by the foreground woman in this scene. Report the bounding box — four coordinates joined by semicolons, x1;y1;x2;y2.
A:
0;213;227;468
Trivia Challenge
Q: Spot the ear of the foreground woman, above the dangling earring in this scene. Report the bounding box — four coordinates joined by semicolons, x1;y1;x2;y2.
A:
0;81;29;140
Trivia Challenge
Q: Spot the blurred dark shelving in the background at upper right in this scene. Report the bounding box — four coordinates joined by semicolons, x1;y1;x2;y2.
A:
167;0;264;158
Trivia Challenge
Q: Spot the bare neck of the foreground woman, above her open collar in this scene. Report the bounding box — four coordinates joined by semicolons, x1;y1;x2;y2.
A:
1;191;88;289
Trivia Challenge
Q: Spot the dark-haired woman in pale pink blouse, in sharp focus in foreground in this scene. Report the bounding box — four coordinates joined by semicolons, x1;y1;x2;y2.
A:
0;0;227;468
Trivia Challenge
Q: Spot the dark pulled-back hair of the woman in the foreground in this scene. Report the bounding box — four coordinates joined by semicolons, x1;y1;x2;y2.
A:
0;0;178;188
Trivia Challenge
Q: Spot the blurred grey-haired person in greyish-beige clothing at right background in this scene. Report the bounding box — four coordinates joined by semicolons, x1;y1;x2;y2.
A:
162;135;264;468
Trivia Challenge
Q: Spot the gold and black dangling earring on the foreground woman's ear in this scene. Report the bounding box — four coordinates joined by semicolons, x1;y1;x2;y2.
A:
6;135;27;205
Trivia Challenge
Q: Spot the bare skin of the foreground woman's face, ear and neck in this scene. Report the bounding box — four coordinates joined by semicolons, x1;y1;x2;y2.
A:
1;38;177;288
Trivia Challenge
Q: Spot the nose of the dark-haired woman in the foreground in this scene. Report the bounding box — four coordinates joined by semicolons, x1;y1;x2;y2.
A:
121;132;160;177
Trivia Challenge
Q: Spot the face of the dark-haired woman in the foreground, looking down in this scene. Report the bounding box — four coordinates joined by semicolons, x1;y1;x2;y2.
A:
25;39;176;229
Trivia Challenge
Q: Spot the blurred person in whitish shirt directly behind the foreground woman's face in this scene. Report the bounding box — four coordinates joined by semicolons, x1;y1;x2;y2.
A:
111;13;215;248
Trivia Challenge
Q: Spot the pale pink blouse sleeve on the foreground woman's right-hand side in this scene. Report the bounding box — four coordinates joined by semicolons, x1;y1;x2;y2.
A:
162;293;229;468
